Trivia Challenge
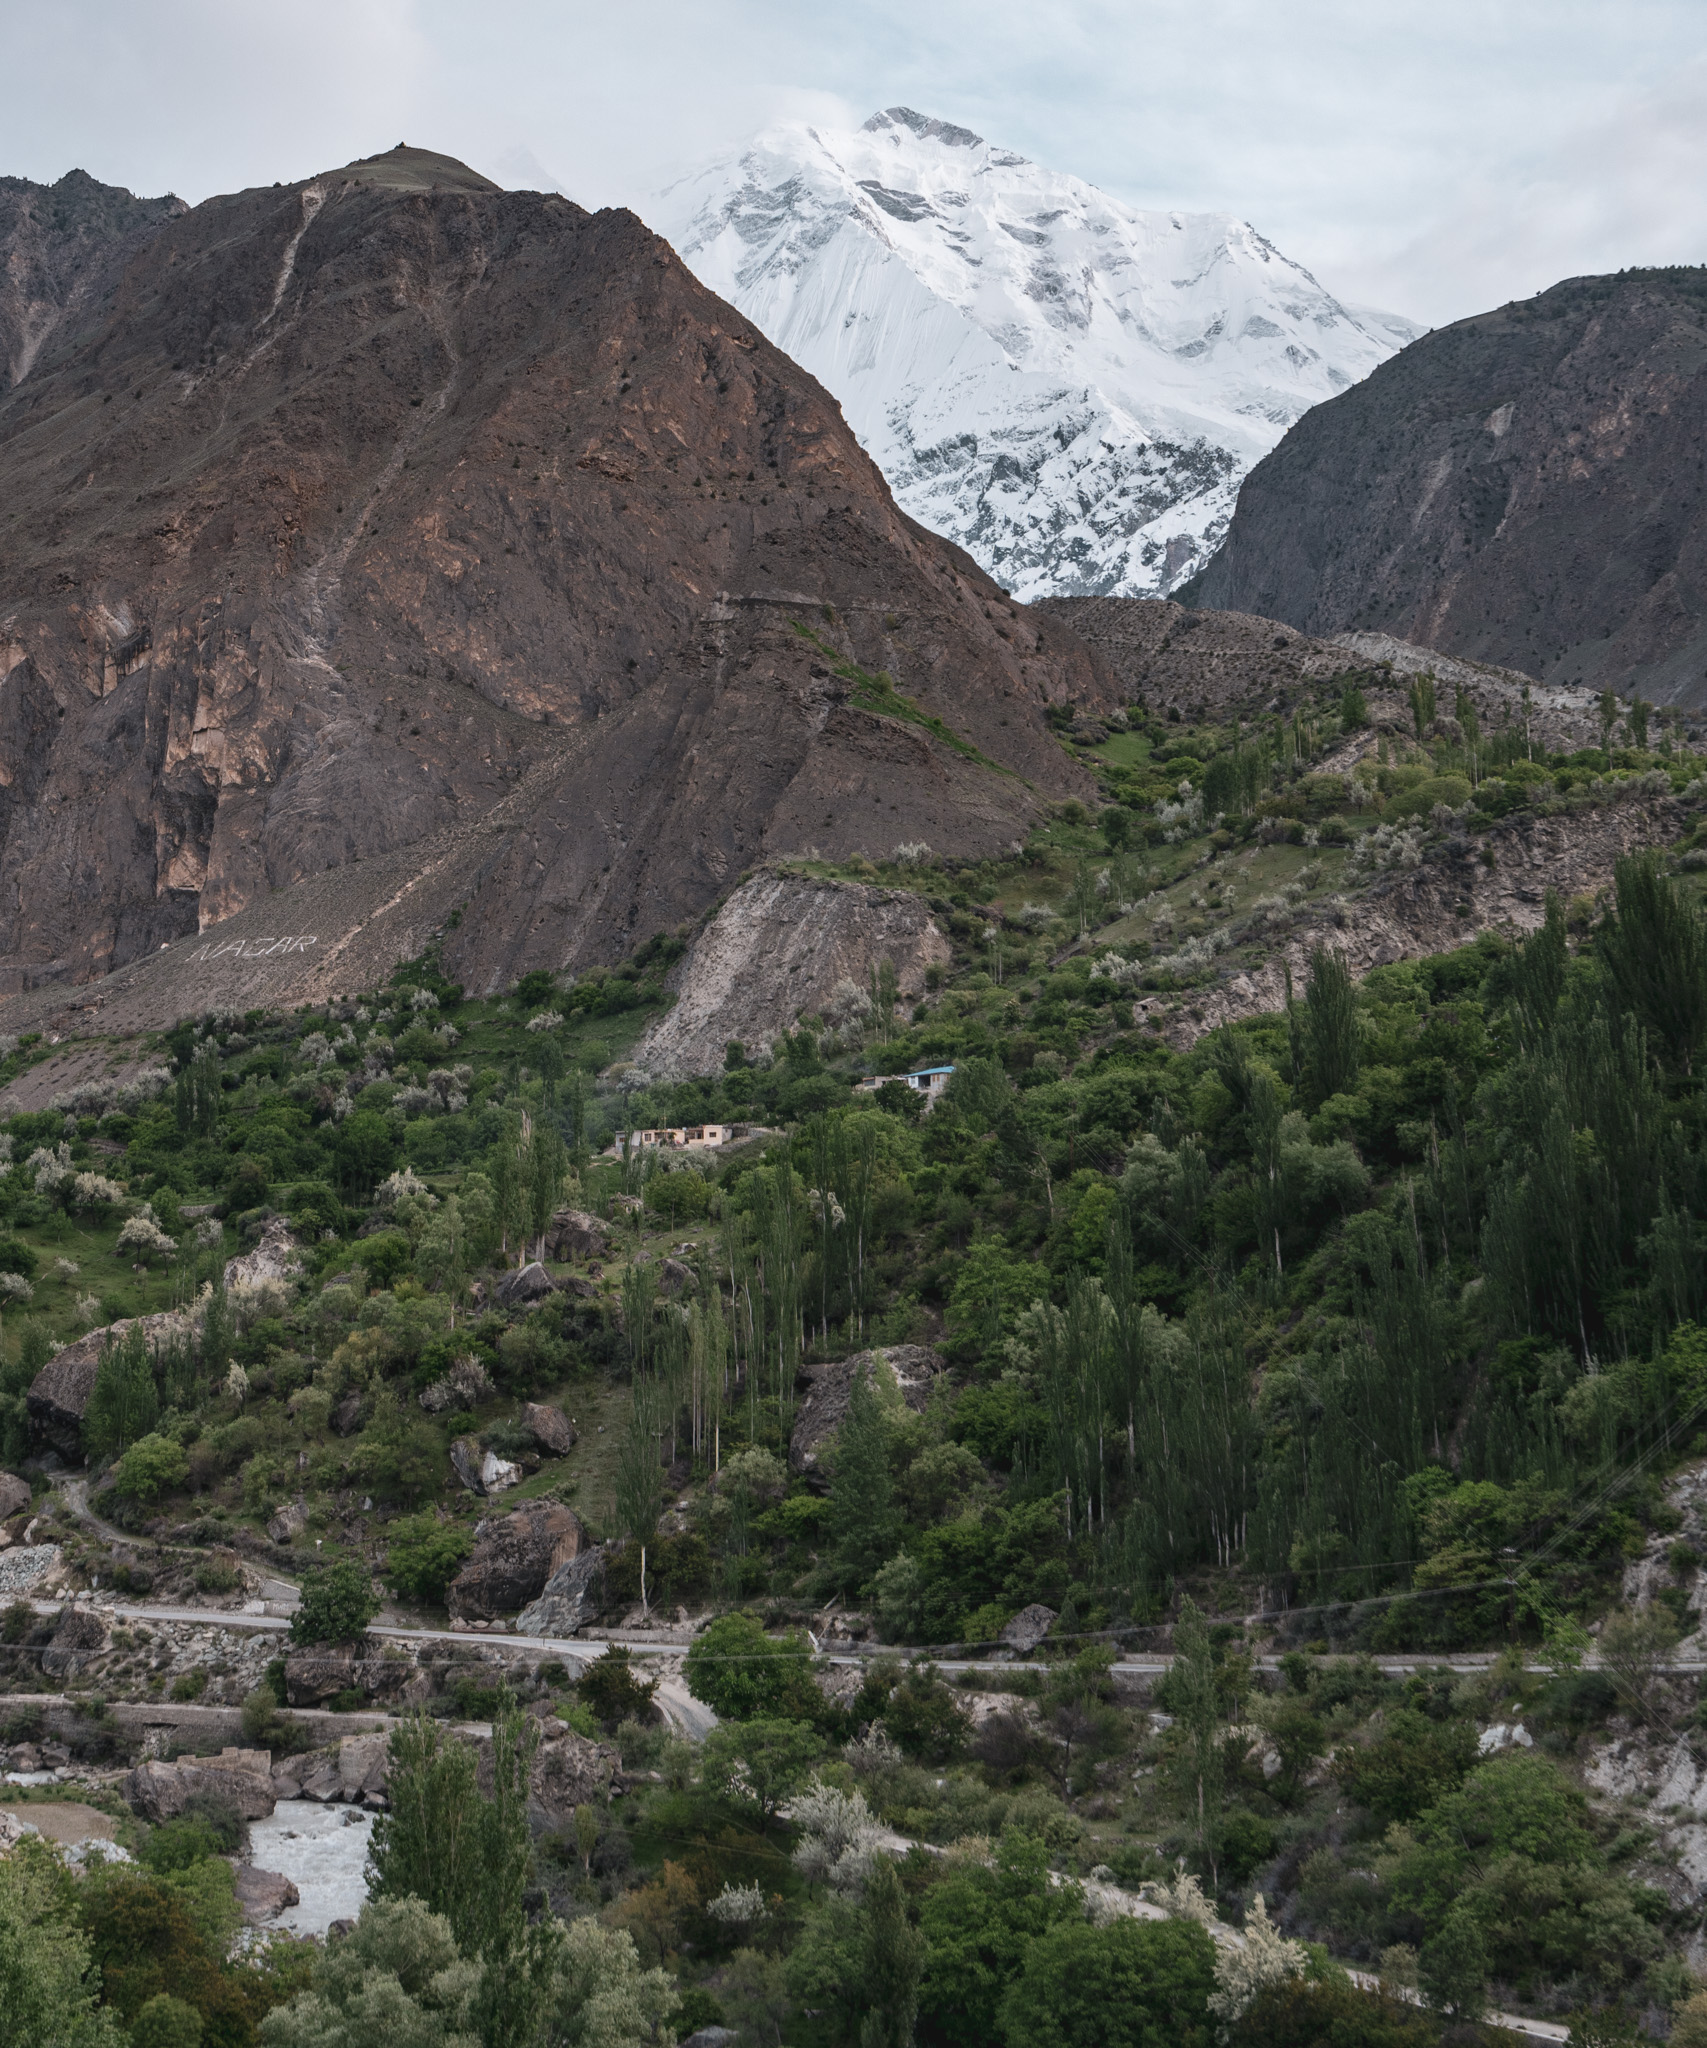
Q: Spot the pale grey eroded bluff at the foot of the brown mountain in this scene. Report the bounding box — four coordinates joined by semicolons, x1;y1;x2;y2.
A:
635;870;951;1073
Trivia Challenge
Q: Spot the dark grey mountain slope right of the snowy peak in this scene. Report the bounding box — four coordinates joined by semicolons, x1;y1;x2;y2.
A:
1195;270;1707;707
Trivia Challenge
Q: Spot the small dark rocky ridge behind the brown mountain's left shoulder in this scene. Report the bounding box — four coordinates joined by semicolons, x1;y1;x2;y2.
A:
0;170;184;391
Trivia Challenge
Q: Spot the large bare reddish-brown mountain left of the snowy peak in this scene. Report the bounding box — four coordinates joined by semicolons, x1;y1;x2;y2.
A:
0;150;1115;991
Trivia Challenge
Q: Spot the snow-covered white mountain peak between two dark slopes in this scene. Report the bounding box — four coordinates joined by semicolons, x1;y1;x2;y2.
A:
650;106;1422;598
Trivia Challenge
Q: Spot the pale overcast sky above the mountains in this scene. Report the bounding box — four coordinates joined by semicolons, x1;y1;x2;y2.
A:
0;0;1707;322
